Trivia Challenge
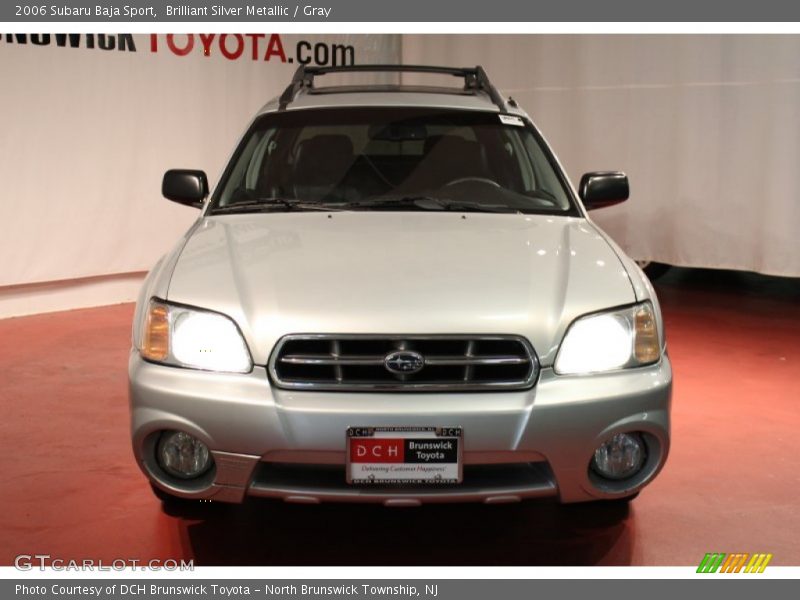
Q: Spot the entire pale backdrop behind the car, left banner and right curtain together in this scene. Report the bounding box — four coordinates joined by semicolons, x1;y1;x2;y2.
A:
0;35;800;298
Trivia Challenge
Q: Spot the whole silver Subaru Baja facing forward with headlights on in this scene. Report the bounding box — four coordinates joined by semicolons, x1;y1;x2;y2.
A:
129;65;672;506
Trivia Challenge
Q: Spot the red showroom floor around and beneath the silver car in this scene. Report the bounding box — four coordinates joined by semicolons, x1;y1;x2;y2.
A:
0;269;800;565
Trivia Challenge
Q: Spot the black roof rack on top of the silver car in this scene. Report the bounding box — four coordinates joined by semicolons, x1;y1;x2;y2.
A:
278;65;507;111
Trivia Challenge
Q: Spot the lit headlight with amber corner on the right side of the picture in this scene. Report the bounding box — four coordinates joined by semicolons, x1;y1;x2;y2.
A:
555;302;661;375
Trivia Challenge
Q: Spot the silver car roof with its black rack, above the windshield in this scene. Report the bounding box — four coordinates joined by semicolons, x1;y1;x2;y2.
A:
258;65;527;117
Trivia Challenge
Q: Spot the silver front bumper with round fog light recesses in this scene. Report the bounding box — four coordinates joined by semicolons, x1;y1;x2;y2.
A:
129;351;672;505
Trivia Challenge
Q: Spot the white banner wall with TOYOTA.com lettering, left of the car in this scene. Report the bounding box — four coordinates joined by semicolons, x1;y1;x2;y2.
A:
0;34;399;288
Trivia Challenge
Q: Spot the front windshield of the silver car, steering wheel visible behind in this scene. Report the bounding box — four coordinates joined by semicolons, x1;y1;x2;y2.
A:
210;107;576;214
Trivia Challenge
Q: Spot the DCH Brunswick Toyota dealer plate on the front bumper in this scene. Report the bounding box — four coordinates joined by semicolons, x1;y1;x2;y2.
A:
347;427;464;485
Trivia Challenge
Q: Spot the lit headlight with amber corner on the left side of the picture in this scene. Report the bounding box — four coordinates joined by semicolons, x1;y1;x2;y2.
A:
139;300;253;373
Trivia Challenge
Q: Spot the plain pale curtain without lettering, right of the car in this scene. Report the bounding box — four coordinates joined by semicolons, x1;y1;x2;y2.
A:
403;35;800;276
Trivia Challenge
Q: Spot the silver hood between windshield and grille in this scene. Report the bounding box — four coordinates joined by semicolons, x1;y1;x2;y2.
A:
168;212;635;365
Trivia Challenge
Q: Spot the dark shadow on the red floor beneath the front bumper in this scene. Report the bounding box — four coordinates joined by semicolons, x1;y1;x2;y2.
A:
175;499;635;566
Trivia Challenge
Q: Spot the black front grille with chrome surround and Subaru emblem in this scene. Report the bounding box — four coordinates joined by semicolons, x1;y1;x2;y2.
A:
269;335;539;391
